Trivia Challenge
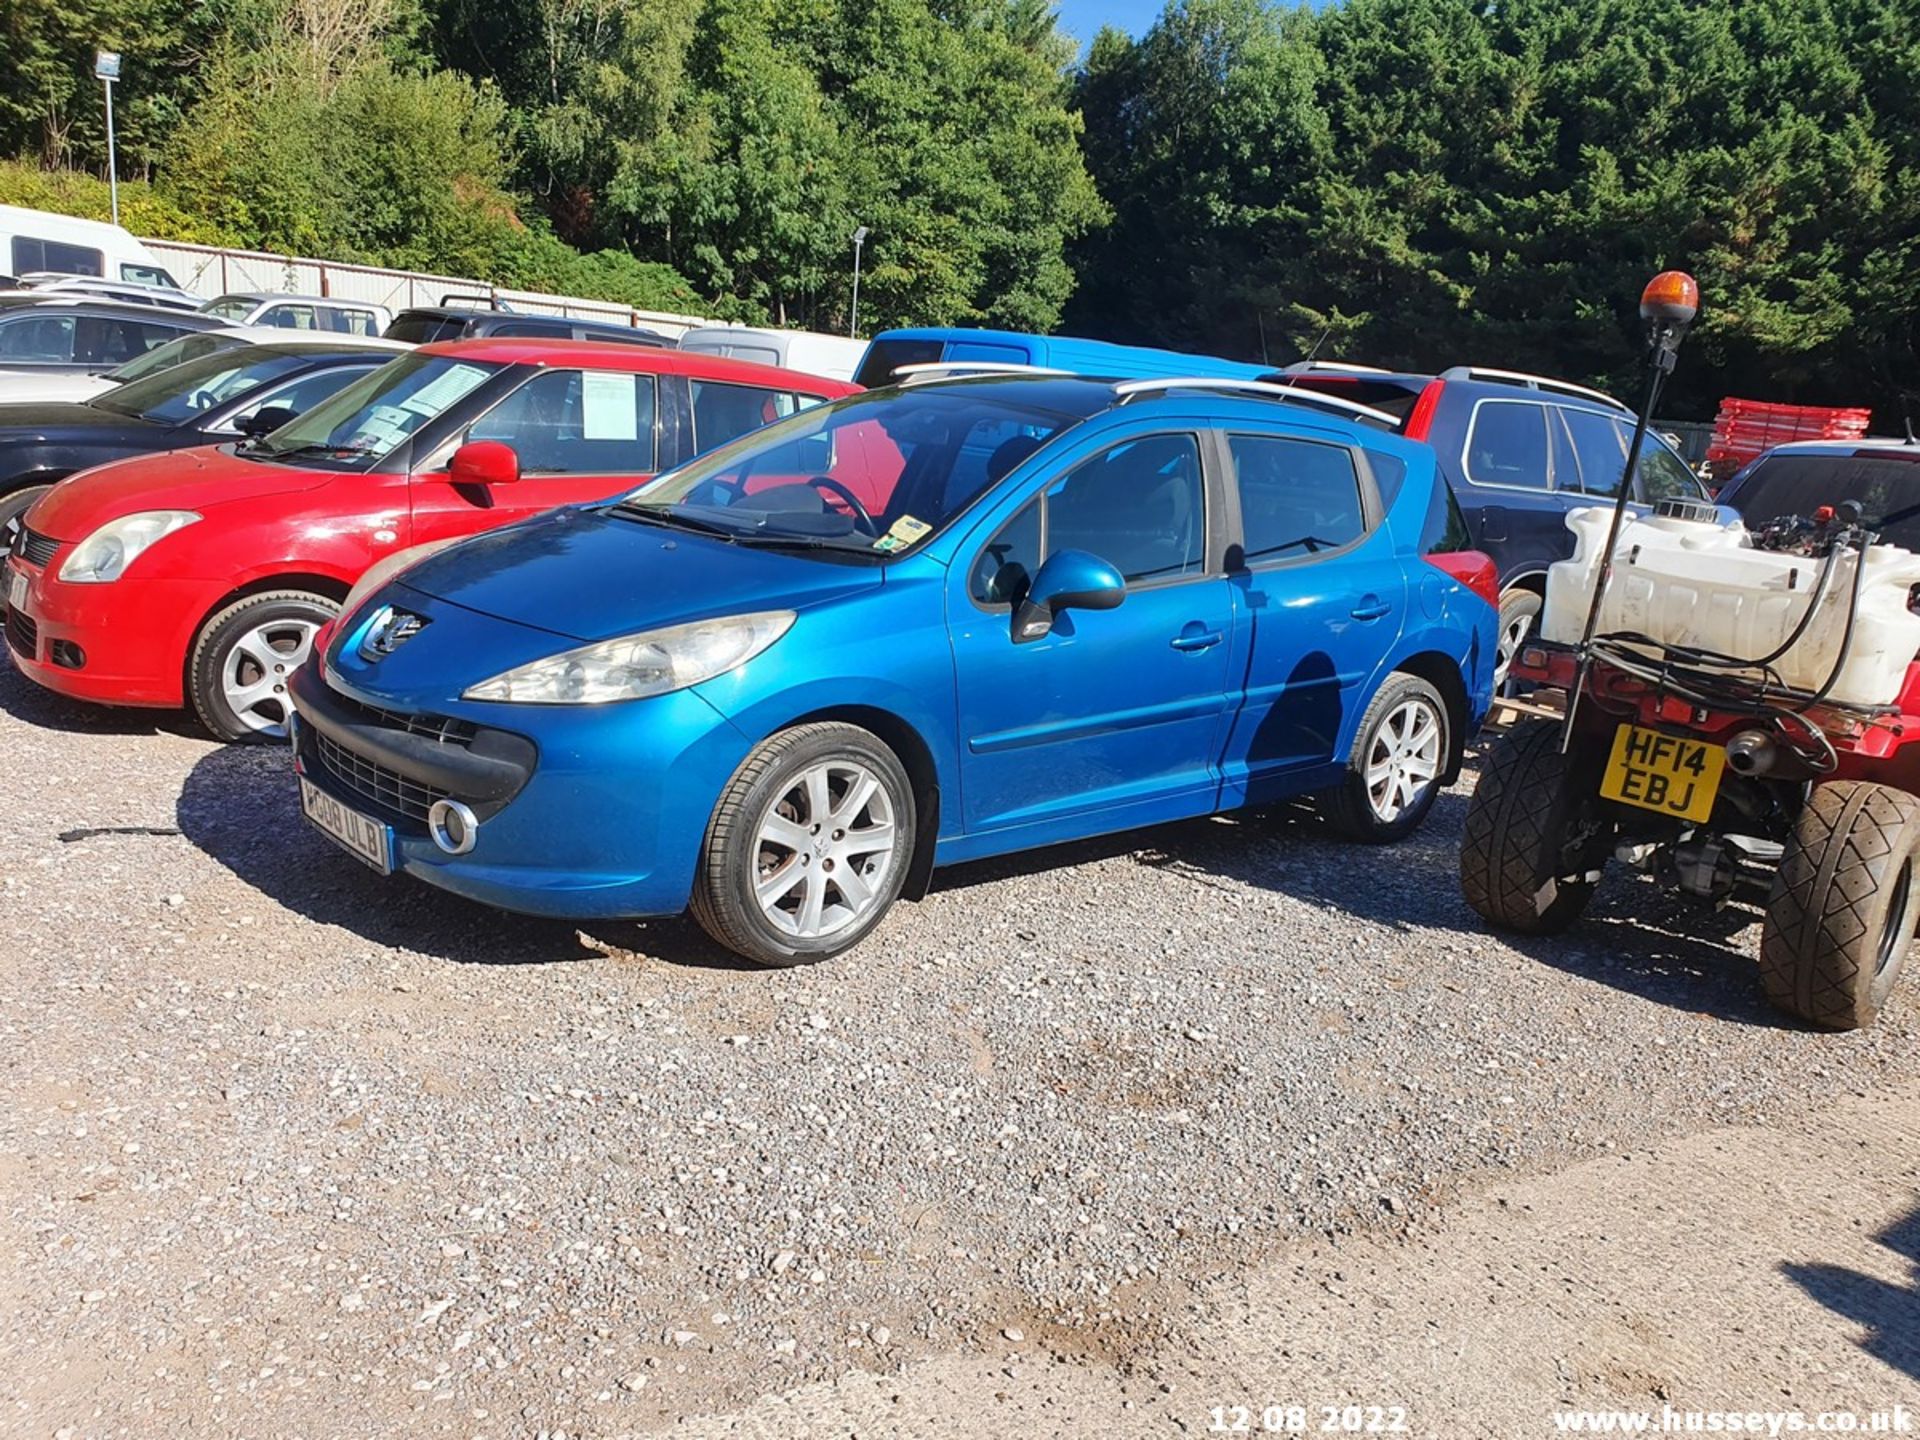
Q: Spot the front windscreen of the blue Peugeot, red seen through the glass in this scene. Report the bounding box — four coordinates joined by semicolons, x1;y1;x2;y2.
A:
616;380;1106;555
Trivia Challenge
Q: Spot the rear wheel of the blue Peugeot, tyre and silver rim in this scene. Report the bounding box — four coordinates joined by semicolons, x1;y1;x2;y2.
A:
1323;670;1453;845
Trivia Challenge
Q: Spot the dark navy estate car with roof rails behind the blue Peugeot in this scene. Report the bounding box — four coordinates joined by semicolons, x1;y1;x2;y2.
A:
1271;361;1707;682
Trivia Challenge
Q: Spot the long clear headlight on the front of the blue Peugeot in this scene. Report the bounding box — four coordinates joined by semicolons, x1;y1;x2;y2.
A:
461;611;793;705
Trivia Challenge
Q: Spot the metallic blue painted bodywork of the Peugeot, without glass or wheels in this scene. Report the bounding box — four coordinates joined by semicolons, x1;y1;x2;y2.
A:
295;385;1494;918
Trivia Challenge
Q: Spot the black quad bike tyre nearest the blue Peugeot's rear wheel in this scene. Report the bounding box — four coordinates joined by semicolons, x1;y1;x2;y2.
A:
1459;720;1605;935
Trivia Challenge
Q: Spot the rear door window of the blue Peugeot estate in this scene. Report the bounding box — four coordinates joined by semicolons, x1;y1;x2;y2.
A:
1227;436;1367;564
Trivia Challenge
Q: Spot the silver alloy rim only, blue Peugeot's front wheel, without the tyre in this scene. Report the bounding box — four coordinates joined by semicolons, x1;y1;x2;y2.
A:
753;760;895;939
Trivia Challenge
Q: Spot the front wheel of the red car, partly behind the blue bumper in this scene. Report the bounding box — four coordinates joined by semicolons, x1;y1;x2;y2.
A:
186;589;340;741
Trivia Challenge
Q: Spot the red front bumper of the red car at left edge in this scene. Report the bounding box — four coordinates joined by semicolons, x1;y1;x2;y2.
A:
0;545;219;708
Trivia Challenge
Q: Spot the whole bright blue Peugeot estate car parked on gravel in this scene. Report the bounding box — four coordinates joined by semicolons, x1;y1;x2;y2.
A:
292;374;1494;966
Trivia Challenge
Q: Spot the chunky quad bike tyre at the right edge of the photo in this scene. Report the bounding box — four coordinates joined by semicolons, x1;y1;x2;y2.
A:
1761;780;1920;1029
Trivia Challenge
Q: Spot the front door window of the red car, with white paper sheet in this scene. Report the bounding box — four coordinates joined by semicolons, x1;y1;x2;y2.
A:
467;371;655;476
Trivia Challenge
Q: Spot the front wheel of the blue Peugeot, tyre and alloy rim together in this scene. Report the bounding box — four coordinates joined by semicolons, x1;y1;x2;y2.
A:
691;722;916;966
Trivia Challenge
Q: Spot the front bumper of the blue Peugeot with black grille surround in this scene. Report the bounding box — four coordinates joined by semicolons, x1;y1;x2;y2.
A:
288;664;747;920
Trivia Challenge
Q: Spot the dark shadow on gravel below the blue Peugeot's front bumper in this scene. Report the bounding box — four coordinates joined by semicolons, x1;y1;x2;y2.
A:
175;745;751;970
